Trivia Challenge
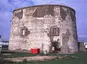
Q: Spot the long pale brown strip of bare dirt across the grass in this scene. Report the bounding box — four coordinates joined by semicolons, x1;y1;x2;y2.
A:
4;55;76;62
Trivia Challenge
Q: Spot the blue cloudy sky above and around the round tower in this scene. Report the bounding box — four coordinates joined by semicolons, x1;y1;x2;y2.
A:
0;0;87;41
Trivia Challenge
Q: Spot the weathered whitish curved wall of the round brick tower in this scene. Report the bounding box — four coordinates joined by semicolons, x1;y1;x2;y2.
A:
9;5;78;53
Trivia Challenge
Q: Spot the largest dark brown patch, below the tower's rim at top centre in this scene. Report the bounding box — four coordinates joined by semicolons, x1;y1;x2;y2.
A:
33;6;54;17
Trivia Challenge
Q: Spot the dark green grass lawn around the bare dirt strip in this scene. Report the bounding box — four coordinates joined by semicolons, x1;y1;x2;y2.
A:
2;52;87;64
